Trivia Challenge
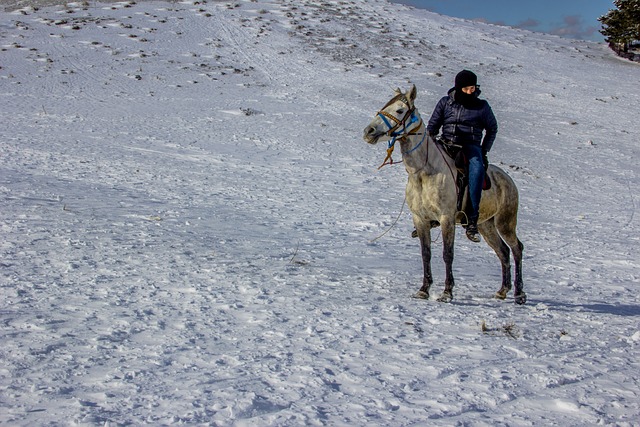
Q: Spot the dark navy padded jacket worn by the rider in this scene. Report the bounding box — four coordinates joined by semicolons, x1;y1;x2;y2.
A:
427;88;498;151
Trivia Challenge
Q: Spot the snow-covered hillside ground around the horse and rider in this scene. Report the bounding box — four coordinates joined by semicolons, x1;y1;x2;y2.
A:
0;0;640;426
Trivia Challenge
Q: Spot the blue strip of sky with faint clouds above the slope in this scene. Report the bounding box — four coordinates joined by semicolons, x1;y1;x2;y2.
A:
397;0;615;41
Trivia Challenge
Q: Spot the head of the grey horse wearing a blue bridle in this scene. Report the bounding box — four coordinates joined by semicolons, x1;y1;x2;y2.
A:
363;85;417;144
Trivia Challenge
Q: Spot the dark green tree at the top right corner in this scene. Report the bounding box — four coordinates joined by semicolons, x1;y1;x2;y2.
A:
598;0;640;54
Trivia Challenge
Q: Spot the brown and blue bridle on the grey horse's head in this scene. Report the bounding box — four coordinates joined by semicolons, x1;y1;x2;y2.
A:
377;93;427;169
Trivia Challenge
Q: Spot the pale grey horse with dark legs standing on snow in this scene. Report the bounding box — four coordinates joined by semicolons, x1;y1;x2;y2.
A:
364;85;527;304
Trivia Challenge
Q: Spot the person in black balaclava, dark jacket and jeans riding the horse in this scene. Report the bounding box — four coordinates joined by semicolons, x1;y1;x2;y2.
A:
427;70;498;242
